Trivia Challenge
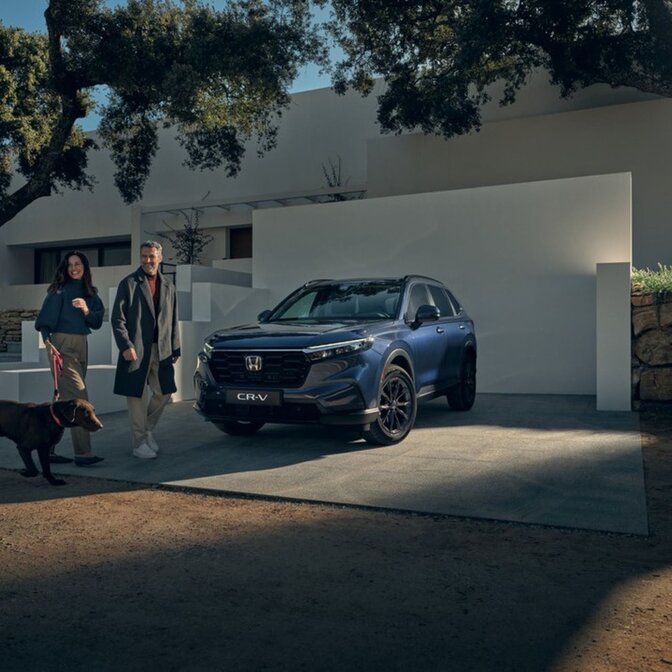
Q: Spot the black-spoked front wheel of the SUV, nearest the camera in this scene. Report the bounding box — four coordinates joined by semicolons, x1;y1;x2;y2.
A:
362;366;417;446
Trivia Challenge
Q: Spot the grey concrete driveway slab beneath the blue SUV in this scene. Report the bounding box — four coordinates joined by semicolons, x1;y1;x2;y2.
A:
0;395;648;534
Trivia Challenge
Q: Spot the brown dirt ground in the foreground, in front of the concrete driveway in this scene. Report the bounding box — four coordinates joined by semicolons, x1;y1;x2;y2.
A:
0;413;672;672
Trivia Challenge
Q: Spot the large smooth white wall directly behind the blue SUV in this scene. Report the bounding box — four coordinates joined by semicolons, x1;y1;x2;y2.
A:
253;174;631;394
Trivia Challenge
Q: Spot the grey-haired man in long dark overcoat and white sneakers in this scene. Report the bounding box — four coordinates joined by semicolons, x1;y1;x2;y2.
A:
111;240;181;460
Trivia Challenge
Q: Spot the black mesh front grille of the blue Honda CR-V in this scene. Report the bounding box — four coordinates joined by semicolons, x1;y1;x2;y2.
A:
210;350;310;388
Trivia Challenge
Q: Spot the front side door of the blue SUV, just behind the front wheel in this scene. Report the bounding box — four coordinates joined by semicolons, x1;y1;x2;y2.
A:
406;282;447;395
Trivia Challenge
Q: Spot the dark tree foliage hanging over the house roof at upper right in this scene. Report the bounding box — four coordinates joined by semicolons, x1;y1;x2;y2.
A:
330;0;672;137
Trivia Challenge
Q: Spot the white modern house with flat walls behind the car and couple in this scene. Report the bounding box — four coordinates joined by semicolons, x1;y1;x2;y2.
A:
0;71;672;410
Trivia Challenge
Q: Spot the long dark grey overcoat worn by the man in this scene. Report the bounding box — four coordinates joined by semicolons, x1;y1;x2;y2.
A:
110;267;180;397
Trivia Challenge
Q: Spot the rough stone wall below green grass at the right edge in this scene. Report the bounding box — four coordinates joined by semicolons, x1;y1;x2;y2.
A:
632;292;672;402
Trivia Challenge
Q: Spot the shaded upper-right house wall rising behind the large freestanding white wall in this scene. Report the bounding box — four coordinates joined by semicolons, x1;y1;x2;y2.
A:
367;99;672;268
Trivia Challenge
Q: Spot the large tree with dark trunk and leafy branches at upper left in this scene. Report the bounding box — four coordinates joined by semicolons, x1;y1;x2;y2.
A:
0;0;324;226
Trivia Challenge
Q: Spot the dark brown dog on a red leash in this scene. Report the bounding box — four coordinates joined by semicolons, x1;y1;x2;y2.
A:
0;399;103;485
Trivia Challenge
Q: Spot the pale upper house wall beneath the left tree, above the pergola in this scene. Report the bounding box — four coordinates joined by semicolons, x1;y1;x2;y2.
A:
0;84;378;309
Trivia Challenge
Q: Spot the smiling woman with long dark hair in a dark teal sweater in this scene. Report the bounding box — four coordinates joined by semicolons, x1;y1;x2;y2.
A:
35;250;105;467
